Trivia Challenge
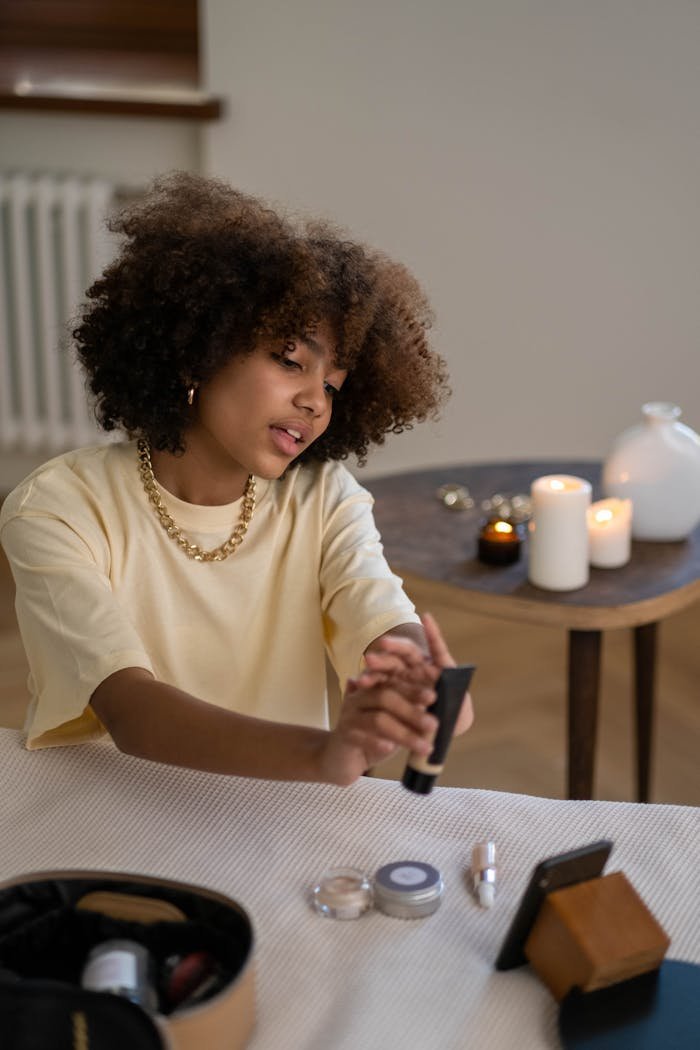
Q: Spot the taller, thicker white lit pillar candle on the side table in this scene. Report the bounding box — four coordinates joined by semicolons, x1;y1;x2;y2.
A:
528;474;591;590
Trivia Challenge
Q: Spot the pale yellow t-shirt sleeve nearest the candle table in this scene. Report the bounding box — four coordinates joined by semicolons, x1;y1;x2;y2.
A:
321;467;420;688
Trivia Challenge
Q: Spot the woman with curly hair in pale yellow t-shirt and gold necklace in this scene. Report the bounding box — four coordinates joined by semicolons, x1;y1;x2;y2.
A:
0;174;472;784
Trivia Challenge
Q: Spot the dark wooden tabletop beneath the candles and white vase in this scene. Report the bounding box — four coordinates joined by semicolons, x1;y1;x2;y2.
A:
364;460;700;627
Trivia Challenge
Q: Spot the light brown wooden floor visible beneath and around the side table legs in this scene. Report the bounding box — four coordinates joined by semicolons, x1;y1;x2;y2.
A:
0;552;700;805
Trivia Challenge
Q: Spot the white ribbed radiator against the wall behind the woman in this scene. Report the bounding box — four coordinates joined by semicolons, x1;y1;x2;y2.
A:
0;173;114;455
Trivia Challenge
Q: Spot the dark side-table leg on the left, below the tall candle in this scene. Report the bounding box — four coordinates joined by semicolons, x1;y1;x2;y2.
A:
569;631;601;798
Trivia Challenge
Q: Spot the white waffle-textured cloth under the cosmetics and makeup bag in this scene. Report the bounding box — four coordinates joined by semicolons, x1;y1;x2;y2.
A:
0;731;700;1050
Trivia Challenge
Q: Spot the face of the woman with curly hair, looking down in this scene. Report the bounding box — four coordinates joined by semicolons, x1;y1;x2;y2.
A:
185;321;347;484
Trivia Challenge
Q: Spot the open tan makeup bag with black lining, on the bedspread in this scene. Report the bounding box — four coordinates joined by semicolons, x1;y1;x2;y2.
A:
0;870;255;1050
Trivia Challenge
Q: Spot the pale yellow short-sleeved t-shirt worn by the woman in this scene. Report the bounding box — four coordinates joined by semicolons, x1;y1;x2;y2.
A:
0;441;418;748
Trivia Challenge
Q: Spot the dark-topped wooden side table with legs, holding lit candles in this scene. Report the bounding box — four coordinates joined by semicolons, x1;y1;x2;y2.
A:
365;461;700;802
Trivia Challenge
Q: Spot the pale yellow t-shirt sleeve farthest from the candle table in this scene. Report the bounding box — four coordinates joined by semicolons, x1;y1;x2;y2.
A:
0;513;152;749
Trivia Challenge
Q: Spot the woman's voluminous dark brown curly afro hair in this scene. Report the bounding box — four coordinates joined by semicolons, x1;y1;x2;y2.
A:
72;173;449;462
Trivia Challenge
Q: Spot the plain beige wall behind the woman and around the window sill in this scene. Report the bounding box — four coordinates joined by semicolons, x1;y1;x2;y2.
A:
0;0;700;487
